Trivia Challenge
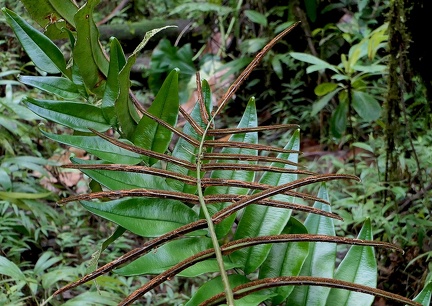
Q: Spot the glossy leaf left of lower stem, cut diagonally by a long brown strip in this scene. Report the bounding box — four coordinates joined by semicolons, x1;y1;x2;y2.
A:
115;236;240;277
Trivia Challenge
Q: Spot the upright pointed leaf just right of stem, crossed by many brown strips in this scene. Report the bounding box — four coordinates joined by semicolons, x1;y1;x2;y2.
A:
205;98;258;238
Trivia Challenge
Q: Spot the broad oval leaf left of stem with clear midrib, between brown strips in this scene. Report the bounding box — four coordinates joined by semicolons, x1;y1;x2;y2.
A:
81;198;198;237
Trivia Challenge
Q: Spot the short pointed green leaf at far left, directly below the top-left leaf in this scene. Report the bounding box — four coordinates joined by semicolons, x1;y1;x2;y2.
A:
18;76;82;99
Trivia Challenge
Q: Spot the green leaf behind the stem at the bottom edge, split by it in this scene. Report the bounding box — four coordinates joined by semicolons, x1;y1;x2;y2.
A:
185;274;272;306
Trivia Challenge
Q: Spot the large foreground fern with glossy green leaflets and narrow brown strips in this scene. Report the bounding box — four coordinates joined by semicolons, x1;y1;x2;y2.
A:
2;0;432;305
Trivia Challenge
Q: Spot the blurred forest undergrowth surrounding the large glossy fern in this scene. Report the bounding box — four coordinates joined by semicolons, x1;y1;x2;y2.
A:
0;0;432;305
